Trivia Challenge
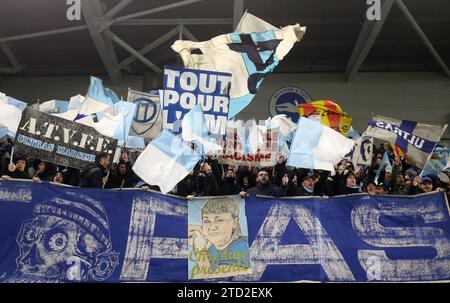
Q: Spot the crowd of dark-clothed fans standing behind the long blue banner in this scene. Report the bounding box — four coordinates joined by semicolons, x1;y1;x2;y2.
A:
0;137;450;199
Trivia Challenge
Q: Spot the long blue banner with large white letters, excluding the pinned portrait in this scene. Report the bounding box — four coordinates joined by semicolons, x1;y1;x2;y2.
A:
0;181;450;282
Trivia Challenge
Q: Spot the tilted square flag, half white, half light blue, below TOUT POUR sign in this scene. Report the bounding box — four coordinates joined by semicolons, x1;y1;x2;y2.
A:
133;130;201;194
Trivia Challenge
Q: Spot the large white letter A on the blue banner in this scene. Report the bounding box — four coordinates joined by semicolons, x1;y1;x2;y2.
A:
234;203;355;281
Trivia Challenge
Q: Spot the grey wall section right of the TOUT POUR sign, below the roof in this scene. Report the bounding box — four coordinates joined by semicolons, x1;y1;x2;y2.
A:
238;72;450;141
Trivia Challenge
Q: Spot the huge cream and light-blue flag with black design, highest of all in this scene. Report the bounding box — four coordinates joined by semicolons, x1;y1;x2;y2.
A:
172;18;306;119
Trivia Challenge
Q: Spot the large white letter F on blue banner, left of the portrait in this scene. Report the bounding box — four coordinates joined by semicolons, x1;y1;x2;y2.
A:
120;196;188;281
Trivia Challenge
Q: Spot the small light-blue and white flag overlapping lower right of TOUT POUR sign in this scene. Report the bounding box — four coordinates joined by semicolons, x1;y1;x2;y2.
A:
181;104;222;155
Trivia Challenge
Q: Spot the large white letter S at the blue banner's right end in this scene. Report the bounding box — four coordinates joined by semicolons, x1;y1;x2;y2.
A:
351;201;450;281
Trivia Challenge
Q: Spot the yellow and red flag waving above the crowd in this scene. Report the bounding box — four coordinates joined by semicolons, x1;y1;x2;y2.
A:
298;100;352;136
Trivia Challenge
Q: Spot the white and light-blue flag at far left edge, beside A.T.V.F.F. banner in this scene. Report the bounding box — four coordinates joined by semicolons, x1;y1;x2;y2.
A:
0;93;27;136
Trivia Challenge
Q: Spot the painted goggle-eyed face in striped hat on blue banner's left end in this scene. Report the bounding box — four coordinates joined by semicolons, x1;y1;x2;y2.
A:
2;195;119;283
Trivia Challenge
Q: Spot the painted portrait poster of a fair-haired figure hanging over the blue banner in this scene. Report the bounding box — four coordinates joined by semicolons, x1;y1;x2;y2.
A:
188;196;252;279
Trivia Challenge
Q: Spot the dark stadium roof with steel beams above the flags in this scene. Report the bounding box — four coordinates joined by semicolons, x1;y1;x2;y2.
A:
0;0;450;82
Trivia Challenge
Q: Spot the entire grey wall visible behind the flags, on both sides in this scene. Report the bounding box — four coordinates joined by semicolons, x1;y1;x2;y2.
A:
0;72;450;143
